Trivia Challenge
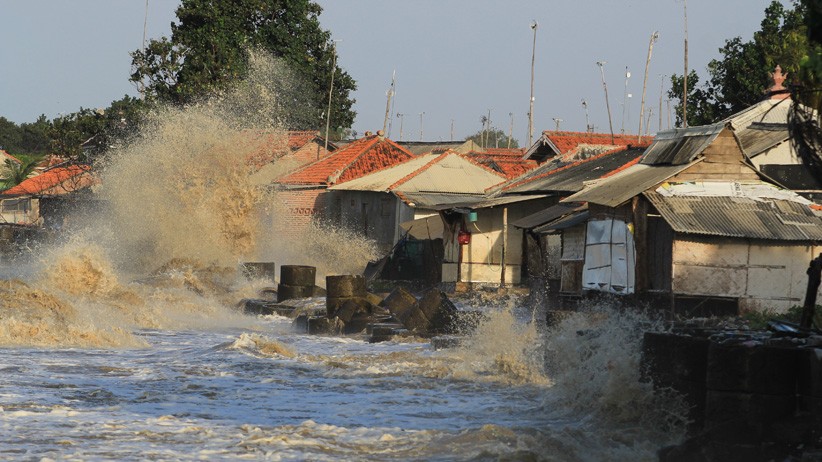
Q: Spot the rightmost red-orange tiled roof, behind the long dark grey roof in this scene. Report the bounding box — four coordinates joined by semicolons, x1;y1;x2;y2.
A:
524;130;650;162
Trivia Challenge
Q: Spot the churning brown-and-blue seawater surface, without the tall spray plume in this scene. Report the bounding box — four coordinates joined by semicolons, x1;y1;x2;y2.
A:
0;254;682;461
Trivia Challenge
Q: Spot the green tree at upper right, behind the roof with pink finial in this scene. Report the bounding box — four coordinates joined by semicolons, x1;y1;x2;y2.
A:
668;0;808;126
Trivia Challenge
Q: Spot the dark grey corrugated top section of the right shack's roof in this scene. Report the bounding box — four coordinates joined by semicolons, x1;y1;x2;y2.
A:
640;123;725;165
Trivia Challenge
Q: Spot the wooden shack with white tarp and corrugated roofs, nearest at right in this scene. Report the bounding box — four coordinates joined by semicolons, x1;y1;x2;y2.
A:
560;122;822;314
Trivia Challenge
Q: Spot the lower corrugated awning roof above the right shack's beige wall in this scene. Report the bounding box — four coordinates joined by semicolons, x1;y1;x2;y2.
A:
644;191;822;241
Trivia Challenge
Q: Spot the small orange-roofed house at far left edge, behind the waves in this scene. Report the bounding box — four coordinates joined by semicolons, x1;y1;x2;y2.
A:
0;165;96;228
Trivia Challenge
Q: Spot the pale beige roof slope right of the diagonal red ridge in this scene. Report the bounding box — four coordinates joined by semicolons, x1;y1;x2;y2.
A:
391;152;505;195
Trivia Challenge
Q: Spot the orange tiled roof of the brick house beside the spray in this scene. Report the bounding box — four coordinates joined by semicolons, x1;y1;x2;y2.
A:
278;135;412;186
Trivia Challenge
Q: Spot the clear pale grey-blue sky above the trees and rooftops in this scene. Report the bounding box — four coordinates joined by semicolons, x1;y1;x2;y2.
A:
0;0;790;145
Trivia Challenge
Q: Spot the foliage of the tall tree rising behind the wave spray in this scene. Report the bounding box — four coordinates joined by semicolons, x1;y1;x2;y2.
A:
131;0;356;130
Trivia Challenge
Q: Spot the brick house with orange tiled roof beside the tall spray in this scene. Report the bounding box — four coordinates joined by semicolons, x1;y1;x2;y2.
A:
272;134;413;235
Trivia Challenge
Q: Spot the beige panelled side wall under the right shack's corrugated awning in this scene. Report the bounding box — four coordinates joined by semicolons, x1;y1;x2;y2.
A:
672;238;822;311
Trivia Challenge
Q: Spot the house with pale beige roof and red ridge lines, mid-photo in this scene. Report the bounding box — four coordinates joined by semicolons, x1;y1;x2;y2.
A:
329;151;505;282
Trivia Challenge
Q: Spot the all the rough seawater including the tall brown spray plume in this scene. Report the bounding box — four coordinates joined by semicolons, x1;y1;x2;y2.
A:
0;52;684;462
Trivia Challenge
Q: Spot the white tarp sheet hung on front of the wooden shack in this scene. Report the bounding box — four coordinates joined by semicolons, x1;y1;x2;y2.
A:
582;219;636;294
